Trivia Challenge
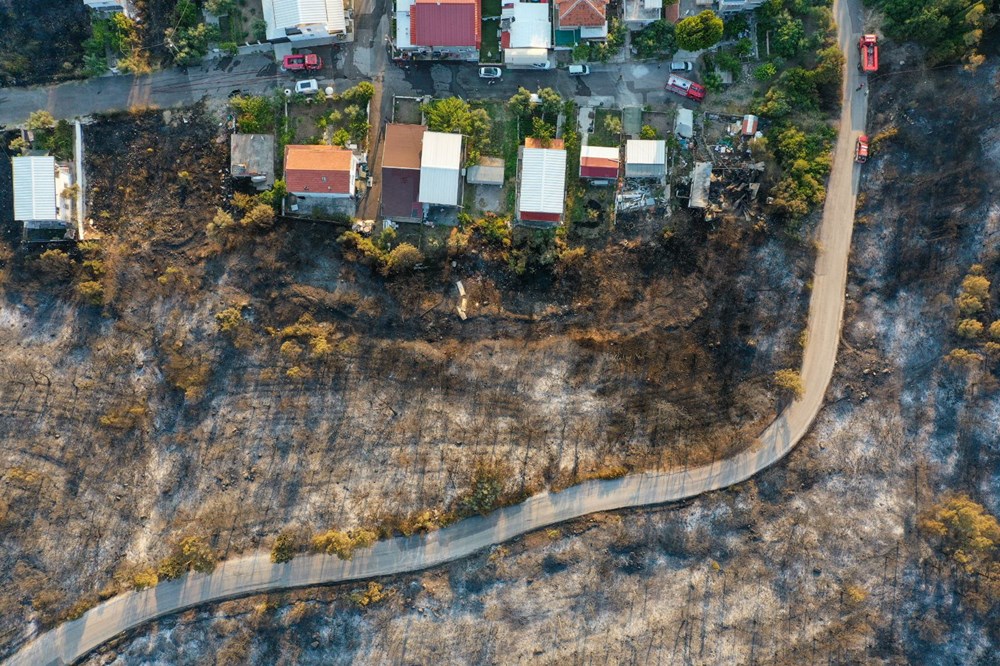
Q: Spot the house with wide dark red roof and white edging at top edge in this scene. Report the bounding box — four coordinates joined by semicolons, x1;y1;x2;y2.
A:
394;0;482;61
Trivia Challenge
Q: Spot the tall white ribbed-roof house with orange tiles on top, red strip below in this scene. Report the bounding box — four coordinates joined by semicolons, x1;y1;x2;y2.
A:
517;137;566;224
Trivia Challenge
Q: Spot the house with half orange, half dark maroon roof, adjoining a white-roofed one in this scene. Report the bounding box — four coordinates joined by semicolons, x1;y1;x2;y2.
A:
381;123;427;221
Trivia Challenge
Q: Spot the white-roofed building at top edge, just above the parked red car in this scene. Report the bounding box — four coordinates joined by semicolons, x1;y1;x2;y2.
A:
263;0;349;47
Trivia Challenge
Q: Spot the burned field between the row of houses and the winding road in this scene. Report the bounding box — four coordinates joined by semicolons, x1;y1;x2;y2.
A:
0;108;809;651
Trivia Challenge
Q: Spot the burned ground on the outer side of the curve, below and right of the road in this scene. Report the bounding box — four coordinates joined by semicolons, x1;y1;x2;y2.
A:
76;47;1000;665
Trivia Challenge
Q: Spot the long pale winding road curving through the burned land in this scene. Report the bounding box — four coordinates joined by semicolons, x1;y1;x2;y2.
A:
7;0;867;666
